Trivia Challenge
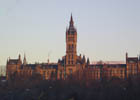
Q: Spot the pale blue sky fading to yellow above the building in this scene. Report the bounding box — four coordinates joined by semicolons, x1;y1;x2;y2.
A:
0;0;140;65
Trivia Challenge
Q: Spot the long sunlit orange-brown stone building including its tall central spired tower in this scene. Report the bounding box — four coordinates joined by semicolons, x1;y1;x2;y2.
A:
6;16;140;80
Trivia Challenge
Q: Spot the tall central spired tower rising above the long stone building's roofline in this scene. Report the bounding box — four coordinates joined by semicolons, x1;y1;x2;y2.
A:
66;15;77;66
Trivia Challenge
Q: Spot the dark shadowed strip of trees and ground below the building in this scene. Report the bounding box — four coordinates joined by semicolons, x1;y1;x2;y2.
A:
0;78;140;100
